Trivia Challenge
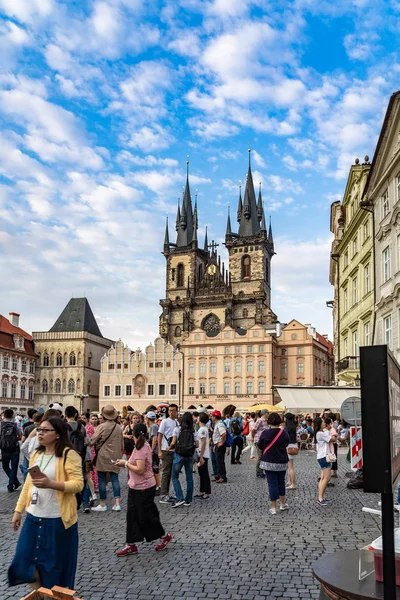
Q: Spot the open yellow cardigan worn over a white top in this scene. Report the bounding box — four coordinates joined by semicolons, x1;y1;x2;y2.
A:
15;449;84;529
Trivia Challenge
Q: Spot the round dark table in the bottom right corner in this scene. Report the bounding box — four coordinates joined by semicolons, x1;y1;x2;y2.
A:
313;550;400;600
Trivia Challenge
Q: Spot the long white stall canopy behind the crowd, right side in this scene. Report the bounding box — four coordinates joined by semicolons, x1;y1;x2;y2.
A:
272;385;361;413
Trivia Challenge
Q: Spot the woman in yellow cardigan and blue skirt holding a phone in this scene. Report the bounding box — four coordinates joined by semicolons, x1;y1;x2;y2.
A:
8;417;84;589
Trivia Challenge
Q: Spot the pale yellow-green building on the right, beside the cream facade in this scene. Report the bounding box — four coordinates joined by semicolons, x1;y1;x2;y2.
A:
330;156;374;385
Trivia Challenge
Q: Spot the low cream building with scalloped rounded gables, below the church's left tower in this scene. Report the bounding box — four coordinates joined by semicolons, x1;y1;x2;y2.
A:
100;338;183;412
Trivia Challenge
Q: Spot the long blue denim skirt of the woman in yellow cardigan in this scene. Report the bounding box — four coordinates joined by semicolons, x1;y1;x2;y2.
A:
8;513;79;590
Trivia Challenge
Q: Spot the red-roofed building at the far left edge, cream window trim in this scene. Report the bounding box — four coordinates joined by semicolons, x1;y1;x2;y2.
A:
0;312;37;414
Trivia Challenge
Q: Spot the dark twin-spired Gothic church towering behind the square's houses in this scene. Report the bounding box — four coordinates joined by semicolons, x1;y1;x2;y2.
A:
160;155;276;344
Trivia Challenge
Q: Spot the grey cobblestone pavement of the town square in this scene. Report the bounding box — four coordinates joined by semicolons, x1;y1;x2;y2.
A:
0;450;379;600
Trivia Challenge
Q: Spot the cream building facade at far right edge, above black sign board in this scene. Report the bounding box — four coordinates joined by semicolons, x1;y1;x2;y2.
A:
363;91;400;360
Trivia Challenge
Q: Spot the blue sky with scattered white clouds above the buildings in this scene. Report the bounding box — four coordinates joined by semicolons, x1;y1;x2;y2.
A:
0;0;400;349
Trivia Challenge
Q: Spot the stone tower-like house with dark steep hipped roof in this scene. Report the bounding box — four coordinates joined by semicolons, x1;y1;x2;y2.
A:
33;298;113;412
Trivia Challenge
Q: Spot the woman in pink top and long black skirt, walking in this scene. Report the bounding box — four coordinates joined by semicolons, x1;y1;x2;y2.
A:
116;423;172;557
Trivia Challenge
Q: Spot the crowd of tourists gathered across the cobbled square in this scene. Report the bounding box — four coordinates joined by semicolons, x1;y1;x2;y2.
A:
0;403;347;589
